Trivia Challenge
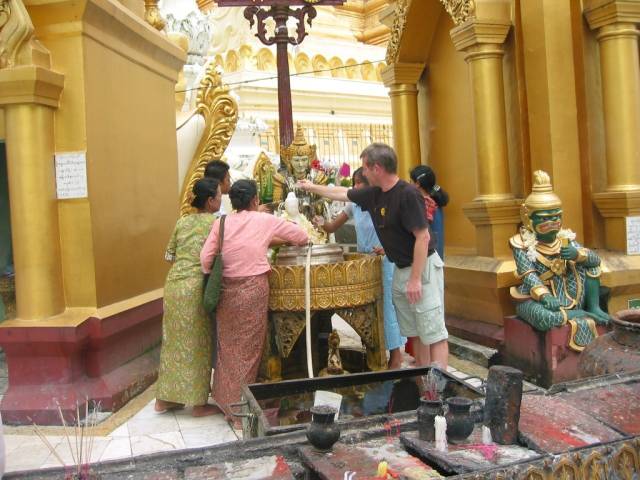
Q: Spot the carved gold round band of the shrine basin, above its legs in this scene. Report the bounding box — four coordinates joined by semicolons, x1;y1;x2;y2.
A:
269;254;382;312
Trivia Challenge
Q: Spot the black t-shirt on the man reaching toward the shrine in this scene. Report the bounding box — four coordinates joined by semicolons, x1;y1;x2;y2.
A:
347;180;428;268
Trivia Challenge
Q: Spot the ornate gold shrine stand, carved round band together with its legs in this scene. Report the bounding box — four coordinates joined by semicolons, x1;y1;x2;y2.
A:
265;254;387;381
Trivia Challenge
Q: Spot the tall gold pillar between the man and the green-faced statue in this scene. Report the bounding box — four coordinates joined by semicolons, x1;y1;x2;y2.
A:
451;19;521;257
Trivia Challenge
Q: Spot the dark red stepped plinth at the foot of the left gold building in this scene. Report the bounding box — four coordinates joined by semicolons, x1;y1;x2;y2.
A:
0;298;162;425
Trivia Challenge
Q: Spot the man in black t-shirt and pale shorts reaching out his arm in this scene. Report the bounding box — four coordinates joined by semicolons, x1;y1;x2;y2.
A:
296;143;449;368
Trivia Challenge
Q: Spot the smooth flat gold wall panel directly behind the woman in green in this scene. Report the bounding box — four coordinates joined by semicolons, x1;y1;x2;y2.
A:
84;32;178;307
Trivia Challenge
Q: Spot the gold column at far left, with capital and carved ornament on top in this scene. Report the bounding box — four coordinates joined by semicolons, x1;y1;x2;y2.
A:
0;0;65;320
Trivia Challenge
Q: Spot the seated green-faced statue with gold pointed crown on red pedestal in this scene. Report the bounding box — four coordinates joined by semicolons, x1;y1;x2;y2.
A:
510;170;609;351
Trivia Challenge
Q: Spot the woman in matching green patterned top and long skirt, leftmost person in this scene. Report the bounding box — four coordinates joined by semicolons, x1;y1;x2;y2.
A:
155;178;221;417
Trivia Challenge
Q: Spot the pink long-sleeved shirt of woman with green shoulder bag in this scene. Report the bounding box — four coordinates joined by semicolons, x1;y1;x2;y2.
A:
200;210;309;277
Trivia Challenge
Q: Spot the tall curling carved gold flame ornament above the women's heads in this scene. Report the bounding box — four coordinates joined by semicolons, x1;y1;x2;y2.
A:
180;63;238;216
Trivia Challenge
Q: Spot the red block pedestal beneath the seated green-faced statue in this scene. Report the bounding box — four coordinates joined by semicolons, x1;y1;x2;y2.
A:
500;316;607;388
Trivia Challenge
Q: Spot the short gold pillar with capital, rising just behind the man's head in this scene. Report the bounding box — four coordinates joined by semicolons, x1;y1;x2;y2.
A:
381;63;424;180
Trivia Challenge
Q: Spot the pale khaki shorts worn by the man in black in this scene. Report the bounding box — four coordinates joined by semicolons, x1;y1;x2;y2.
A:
392;252;449;345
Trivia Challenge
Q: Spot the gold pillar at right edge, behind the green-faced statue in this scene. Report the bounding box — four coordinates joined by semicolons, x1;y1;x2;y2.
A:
584;0;640;251
